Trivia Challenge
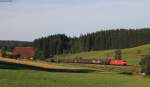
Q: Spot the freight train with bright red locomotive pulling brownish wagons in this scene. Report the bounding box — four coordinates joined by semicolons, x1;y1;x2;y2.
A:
50;58;127;66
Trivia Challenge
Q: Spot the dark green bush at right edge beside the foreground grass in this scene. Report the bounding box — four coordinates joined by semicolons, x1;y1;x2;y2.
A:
140;55;150;74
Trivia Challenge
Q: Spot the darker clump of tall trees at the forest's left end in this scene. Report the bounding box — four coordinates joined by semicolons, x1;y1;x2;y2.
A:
34;34;69;58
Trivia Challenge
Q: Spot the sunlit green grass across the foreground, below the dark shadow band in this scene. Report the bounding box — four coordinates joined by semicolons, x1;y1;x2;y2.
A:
0;69;150;87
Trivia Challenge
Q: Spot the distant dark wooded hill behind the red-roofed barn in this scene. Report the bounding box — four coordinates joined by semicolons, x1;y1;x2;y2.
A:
0;40;32;50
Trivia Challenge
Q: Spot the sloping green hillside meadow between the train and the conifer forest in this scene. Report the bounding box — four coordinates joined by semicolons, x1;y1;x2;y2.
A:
56;45;150;64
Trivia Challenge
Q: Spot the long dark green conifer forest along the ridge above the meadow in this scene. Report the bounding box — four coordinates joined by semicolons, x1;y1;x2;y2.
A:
33;28;150;58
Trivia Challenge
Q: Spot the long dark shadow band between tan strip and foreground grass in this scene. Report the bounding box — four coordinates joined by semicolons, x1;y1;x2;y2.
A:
0;62;95;73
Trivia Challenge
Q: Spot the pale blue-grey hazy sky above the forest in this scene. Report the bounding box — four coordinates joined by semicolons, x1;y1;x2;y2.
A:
0;0;150;41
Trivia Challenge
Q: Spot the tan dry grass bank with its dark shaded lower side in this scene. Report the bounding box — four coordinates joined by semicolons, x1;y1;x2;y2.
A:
0;57;93;73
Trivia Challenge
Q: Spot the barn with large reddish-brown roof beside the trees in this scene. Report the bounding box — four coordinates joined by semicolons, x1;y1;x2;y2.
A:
13;47;35;59
